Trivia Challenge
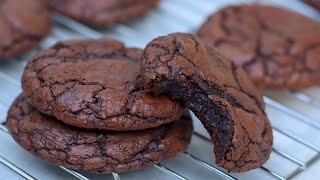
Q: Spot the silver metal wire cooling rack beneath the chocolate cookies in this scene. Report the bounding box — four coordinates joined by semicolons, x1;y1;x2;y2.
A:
0;0;320;180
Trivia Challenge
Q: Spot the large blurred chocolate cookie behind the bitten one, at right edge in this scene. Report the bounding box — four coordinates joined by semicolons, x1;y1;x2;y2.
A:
198;4;320;90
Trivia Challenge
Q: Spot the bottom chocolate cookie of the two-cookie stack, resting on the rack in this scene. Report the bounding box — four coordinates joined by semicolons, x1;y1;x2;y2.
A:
7;95;192;174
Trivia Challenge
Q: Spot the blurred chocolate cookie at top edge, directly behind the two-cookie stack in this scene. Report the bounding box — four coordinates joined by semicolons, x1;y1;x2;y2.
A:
46;0;159;26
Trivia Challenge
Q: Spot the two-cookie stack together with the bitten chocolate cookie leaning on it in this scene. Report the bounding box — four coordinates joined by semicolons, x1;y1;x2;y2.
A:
8;33;272;173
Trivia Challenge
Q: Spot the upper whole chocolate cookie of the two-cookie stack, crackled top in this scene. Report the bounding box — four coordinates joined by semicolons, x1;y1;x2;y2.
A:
22;39;184;131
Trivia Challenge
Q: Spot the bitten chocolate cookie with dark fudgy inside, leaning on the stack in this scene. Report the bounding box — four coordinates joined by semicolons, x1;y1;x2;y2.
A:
141;33;272;172
